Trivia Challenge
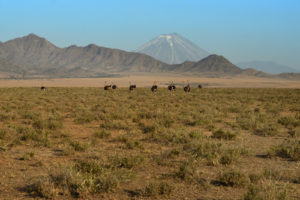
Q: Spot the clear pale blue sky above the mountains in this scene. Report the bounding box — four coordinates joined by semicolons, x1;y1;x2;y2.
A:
0;0;300;69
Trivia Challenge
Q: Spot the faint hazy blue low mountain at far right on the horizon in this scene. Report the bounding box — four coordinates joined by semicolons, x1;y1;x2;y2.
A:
236;61;300;74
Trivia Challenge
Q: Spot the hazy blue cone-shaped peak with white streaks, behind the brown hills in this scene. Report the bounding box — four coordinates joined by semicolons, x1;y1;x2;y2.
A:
136;33;209;64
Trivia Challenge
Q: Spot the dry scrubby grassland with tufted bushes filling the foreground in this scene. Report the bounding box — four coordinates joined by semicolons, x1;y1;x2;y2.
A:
0;85;300;200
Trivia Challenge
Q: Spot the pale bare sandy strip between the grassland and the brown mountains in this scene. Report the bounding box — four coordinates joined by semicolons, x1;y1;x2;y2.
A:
0;74;300;88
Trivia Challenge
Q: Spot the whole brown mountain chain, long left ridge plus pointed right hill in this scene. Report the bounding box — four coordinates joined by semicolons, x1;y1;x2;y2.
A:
0;34;299;78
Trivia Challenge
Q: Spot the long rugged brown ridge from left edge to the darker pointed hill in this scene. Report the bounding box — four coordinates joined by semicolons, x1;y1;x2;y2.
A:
0;34;167;77
